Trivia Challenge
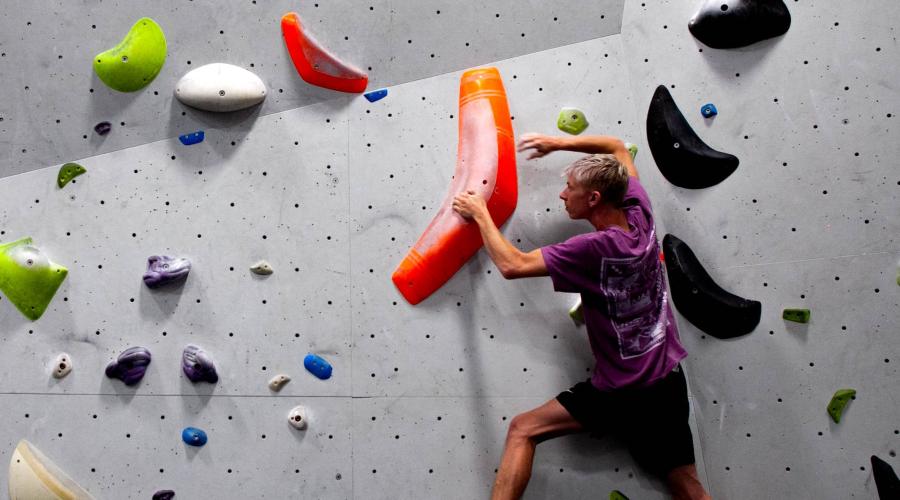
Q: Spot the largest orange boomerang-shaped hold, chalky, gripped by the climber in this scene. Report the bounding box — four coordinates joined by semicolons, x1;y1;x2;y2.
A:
392;68;518;304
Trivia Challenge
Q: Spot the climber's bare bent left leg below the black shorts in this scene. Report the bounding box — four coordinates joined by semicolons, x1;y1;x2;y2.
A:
491;399;583;500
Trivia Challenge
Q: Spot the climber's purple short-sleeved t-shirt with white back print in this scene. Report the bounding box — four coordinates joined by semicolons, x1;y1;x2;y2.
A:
541;177;687;391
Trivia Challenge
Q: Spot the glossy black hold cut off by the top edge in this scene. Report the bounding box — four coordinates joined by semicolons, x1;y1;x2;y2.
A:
688;0;791;49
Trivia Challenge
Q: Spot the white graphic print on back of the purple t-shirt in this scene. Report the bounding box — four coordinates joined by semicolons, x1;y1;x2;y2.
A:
600;233;667;359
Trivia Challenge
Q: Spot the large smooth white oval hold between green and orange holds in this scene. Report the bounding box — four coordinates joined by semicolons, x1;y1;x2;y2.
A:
175;63;266;112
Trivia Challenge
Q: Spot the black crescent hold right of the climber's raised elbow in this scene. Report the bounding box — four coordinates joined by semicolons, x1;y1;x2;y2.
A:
647;85;739;189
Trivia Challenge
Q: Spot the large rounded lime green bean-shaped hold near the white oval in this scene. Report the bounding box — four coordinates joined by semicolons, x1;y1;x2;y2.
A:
94;17;166;92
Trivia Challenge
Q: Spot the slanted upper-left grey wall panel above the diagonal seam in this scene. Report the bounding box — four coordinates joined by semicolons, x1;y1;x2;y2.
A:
0;0;624;177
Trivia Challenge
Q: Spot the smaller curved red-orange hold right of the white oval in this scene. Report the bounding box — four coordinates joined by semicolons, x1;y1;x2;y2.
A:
281;12;369;93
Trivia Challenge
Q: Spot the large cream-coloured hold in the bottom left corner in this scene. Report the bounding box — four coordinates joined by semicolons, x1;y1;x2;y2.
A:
9;439;94;500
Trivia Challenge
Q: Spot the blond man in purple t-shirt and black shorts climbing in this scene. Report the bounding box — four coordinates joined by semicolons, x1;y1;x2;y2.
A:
453;134;709;500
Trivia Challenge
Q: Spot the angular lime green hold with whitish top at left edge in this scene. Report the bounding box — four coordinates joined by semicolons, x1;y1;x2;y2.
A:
0;238;69;321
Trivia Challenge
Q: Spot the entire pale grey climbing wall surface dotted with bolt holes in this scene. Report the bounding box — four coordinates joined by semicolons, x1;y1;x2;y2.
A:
0;0;900;499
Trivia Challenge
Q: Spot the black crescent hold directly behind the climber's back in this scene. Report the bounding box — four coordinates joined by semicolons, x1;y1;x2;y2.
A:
663;234;762;339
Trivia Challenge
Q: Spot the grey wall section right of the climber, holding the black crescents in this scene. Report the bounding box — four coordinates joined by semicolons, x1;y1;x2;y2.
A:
622;0;900;498
